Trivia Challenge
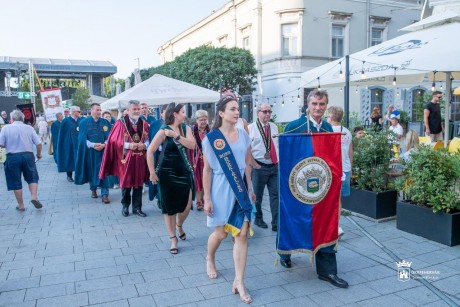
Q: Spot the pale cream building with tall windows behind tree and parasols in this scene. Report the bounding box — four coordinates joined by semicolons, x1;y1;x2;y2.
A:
158;0;423;122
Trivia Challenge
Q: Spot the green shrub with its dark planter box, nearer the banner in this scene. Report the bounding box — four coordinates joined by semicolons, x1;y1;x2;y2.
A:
342;129;397;220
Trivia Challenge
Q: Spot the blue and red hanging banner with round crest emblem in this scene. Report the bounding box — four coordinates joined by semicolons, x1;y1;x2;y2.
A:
277;133;342;254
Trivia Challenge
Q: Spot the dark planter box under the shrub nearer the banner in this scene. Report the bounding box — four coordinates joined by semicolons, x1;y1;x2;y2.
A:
342;188;397;220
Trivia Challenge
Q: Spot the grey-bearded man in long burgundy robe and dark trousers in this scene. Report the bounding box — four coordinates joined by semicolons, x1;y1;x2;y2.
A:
99;100;149;217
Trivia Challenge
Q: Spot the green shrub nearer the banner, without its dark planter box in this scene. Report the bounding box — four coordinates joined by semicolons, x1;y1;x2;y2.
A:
352;129;393;192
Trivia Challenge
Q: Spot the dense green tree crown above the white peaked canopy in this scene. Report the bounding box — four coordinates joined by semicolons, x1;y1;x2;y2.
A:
141;46;257;95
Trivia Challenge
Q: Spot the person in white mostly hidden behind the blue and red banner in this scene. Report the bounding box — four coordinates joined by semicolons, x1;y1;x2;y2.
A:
327;106;353;237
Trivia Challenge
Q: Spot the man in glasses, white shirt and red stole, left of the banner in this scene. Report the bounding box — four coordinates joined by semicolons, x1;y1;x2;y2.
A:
248;103;279;231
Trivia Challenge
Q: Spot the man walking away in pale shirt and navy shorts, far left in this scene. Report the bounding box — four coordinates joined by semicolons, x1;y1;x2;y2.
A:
0;110;42;211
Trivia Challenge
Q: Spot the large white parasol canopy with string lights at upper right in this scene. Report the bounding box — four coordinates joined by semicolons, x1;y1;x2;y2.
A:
301;20;460;88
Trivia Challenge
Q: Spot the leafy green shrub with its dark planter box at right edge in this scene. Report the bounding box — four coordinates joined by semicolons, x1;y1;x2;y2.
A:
396;145;460;246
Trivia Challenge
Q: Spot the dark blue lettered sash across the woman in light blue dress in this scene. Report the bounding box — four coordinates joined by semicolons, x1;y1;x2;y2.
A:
206;129;252;236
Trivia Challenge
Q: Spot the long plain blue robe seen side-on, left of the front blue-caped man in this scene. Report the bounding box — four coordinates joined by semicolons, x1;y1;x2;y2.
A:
56;116;81;173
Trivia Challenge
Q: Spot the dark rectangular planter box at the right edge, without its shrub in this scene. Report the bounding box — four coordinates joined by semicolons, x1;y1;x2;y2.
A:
396;201;460;246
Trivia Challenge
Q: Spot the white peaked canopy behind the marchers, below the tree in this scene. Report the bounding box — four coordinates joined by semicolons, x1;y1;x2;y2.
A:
101;74;220;110
